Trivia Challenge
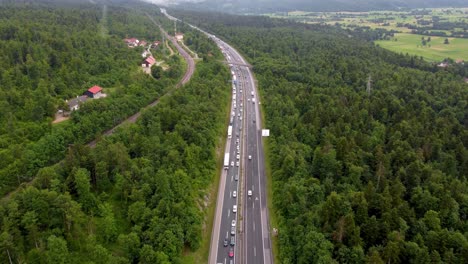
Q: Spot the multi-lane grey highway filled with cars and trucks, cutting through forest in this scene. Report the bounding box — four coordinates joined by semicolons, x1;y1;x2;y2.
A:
161;9;273;264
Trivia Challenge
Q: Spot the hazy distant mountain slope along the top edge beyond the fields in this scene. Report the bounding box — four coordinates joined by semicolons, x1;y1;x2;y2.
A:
160;0;468;13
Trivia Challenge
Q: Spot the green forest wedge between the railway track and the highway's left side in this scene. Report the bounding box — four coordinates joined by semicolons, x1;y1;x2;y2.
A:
0;2;230;263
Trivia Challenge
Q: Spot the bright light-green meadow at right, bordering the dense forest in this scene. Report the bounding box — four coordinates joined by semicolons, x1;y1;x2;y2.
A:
375;33;468;61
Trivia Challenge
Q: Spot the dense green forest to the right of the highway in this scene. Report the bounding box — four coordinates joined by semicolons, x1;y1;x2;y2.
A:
170;10;468;264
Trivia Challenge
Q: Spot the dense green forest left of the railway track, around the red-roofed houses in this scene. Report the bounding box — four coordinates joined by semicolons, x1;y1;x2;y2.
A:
0;4;183;195
